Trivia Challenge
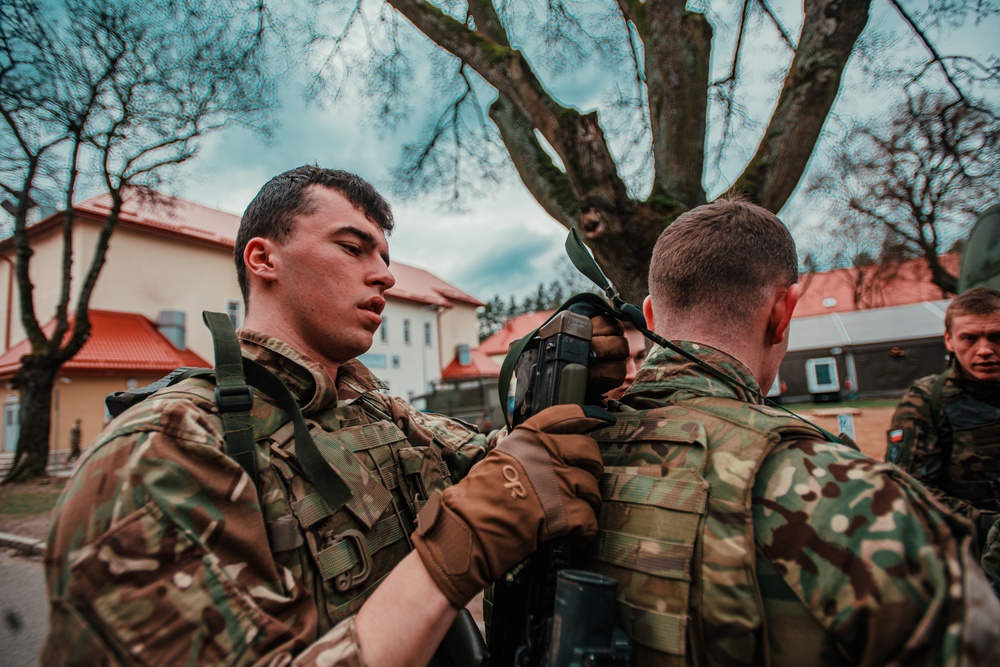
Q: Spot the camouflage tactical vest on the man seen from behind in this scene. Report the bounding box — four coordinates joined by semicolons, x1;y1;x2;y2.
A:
582;397;827;667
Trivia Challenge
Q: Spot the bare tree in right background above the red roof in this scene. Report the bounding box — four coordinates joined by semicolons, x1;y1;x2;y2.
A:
810;89;1000;294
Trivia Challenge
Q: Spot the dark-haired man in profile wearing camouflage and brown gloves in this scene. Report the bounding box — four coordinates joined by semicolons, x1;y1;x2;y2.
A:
42;167;625;666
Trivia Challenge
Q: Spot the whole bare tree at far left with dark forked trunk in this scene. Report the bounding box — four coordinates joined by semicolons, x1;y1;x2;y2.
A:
0;0;274;482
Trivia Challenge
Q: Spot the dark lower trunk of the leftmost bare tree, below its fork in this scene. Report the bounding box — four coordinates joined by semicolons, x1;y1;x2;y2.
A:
2;356;60;484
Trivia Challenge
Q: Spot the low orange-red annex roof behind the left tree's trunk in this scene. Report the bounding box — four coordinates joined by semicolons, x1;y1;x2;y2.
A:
0;310;212;379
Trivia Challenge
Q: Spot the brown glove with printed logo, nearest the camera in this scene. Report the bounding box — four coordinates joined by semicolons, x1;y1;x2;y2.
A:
413;405;614;608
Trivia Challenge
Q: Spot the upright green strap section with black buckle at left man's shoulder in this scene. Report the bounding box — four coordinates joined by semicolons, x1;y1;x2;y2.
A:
202;310;260;495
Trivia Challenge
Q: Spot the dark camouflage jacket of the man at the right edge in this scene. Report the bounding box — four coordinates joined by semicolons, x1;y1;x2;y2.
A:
886;365;1000;539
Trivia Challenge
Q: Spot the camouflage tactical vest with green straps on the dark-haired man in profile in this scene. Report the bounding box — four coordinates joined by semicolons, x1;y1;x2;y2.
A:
107;312;451;634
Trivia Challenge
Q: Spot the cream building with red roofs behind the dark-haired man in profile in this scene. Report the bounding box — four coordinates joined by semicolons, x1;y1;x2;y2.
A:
0;192;484;451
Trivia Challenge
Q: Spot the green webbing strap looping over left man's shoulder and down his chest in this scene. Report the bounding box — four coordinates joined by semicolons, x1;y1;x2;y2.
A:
203;311;351;512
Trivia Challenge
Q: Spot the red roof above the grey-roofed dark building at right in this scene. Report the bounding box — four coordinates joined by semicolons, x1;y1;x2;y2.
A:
794;253;962;317
